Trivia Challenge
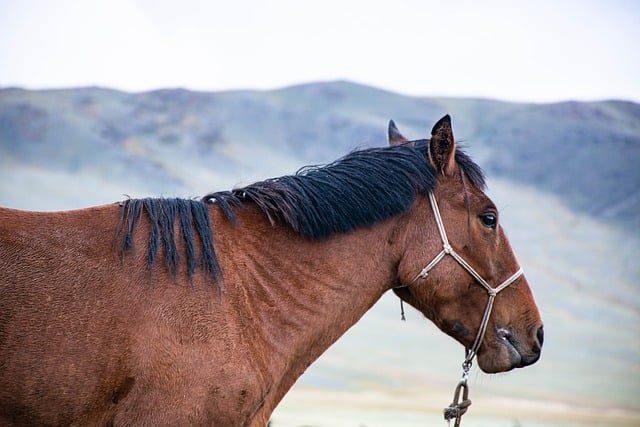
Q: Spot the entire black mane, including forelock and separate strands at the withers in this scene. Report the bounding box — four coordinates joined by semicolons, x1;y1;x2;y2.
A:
116;140;485;287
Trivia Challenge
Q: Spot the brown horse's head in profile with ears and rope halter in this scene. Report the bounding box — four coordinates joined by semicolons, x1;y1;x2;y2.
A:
389;116;544;373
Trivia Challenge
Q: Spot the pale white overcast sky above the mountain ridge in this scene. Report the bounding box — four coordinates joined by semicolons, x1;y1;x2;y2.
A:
0;0;640;102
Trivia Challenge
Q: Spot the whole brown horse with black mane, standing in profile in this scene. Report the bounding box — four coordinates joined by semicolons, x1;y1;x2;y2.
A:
0;116;542;426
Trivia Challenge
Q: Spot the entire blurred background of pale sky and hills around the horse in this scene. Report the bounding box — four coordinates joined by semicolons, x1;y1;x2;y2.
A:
0;0;640;427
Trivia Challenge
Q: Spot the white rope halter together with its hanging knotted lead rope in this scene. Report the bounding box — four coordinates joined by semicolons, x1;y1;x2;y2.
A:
400;191;523;427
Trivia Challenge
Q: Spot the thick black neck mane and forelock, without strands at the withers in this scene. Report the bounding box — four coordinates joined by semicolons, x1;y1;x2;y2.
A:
202;140;485;239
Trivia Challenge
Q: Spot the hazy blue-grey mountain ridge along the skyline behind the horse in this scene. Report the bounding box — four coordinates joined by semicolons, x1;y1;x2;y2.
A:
0;81;640;228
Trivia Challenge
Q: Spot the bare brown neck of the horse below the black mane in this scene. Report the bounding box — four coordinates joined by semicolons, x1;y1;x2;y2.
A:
216;206;396;406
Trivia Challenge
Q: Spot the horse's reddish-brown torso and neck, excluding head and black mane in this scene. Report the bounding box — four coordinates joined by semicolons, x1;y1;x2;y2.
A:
0;204;400;425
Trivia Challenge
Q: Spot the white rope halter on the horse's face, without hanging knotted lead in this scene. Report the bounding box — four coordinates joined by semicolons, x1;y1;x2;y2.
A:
402;191;523;366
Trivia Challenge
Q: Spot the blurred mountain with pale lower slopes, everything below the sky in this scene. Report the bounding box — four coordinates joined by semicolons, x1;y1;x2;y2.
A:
0;82;640;427
